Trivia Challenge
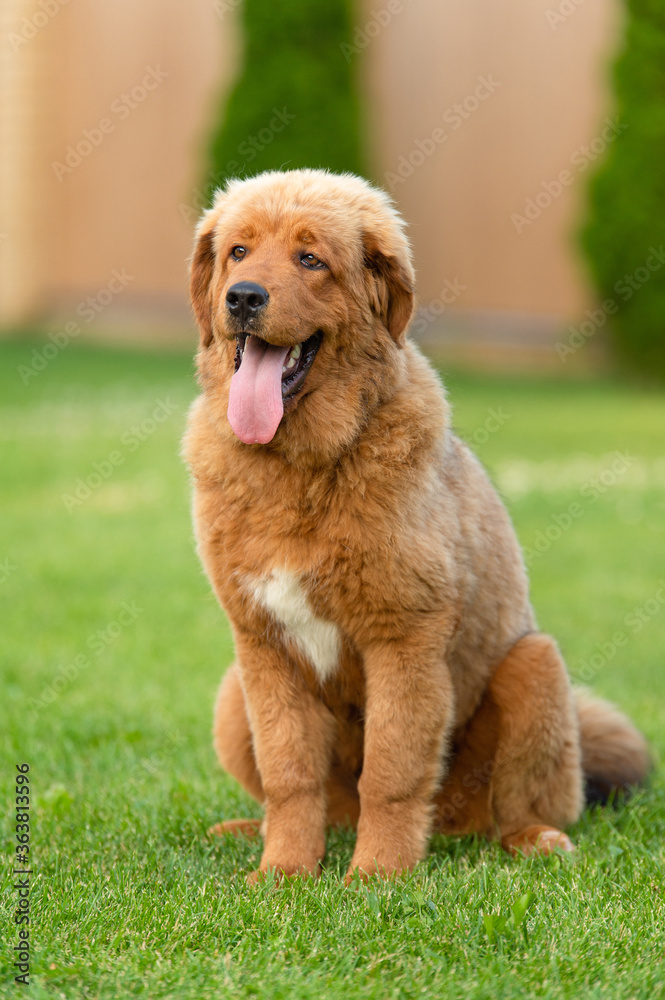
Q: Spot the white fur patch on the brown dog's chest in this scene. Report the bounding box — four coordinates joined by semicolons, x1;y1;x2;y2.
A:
249;569;340;681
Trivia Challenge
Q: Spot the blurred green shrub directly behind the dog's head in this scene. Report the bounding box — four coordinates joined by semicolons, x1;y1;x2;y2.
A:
206;0;363;203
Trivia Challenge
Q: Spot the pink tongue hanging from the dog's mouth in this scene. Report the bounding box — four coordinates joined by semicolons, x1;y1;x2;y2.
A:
227;337;289;444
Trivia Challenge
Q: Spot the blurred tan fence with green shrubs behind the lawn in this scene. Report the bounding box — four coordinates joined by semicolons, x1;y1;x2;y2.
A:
0;0;665;371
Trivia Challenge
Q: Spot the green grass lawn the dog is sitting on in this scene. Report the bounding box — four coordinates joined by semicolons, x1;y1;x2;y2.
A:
0;343;665;1000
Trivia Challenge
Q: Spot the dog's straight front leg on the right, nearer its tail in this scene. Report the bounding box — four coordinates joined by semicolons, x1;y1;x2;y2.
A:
346;637;453;883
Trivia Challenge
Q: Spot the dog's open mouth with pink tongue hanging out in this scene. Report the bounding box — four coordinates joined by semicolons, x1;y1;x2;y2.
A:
228;330;323;444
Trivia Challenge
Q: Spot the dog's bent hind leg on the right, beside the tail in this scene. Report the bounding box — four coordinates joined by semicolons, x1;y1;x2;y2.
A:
435;633;583;854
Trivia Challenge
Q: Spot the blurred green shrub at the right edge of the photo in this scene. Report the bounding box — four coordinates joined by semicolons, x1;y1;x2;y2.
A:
582;0;665;377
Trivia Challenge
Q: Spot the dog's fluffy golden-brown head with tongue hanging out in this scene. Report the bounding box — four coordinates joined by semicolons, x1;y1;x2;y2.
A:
191;170;414;451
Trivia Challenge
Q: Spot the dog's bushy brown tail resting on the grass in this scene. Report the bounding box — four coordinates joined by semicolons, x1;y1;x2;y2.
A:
575;688;651;805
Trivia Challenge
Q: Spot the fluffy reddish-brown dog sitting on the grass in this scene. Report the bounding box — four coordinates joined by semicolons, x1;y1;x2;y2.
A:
185;170;648;878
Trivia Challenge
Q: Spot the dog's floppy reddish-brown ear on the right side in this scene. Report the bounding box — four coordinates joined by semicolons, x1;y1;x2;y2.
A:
363;233;415;347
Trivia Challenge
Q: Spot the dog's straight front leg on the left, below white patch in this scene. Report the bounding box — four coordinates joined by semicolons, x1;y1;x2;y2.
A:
236;631;335;881
